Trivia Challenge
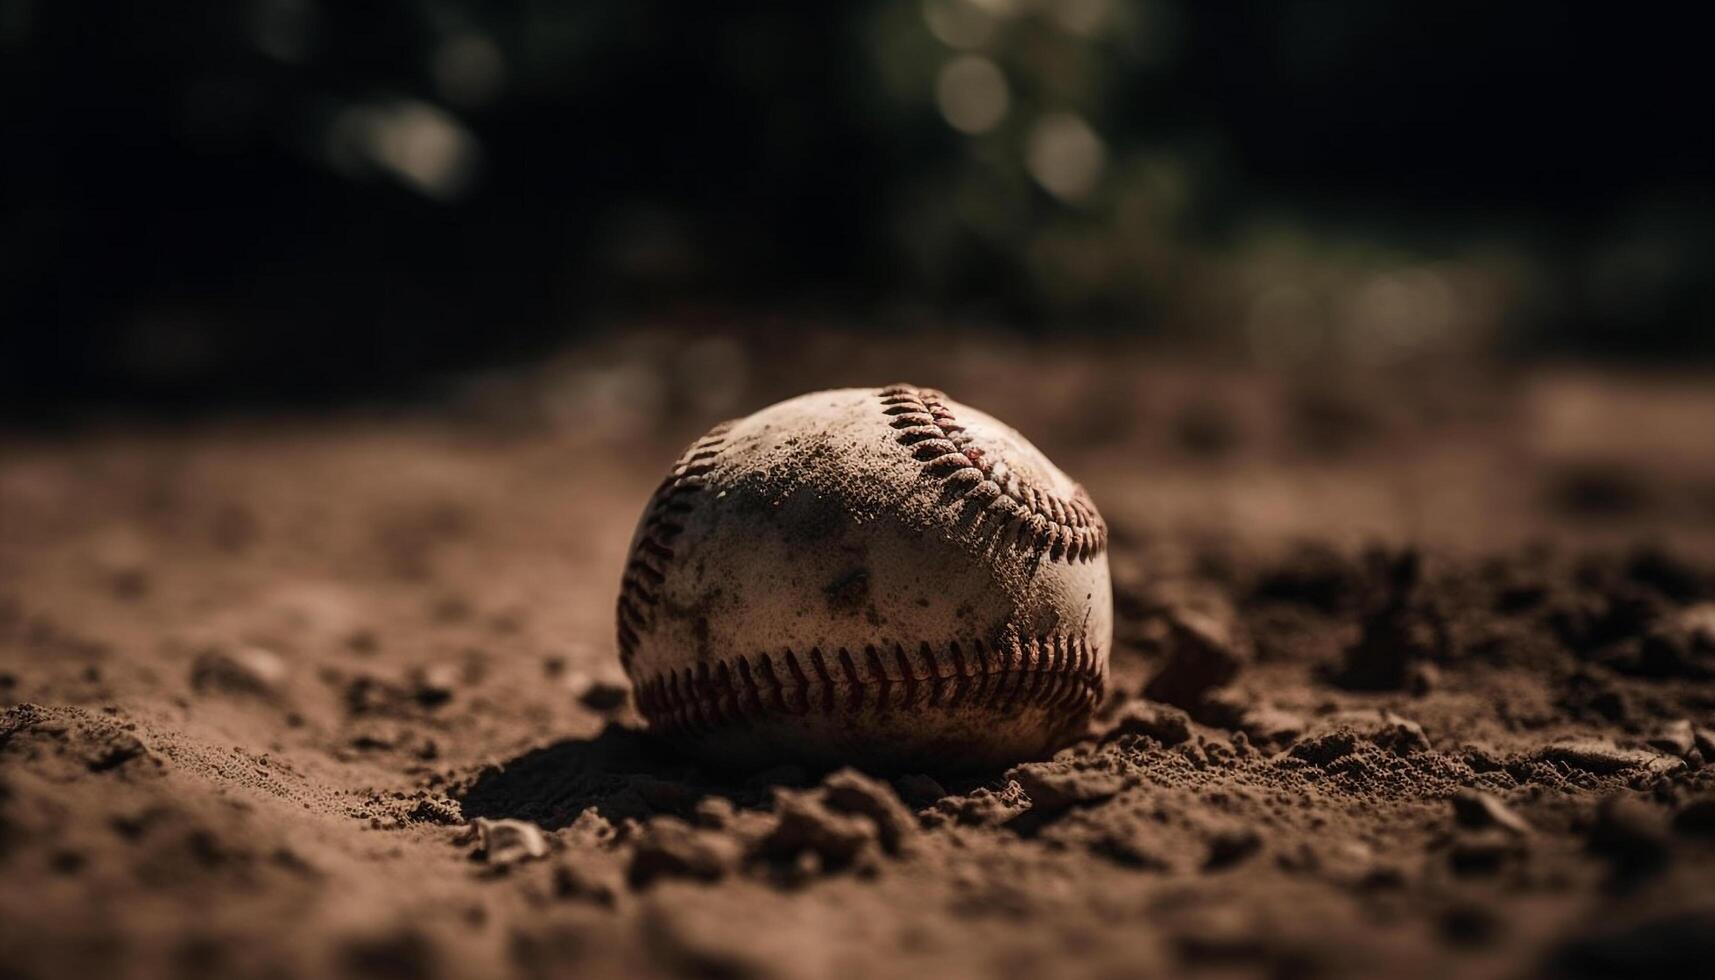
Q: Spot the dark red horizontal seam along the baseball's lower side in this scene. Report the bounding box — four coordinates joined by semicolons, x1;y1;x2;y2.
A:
635;635;1104;735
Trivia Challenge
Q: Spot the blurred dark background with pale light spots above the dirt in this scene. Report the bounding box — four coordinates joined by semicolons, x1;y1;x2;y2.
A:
0;0;1715;408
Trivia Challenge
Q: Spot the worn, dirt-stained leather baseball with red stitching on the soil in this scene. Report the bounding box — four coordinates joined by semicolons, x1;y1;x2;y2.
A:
619;384;1113;769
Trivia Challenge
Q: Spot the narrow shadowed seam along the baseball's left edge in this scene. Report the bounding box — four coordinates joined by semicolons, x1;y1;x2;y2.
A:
619;422;732;669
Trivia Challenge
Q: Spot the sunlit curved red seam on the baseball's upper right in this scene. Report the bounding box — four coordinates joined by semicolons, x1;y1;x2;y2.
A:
882;384;1108;561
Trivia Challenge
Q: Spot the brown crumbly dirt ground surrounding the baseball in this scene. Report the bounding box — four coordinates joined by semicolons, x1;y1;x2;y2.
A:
0;333;1715;977
